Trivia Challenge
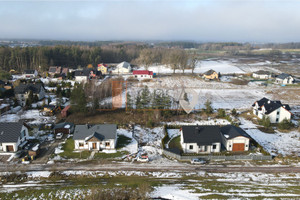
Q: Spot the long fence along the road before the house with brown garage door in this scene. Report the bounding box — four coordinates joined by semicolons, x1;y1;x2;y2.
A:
163;149;272;161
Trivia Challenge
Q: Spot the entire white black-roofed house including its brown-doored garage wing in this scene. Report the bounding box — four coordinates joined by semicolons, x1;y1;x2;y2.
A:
180;125;251;154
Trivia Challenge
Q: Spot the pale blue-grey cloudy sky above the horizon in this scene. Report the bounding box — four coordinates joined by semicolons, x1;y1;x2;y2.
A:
0;0;300;42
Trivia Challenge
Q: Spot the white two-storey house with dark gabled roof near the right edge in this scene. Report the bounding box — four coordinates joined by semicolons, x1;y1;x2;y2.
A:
252;97;292;123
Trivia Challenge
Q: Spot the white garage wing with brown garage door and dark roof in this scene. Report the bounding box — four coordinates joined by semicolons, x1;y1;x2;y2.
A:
220;125;251;151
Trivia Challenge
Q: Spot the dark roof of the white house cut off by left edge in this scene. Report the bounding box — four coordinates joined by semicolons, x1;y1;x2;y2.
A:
0;122;23;143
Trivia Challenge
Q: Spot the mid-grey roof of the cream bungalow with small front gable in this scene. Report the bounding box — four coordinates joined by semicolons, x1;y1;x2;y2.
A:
73;124;117;140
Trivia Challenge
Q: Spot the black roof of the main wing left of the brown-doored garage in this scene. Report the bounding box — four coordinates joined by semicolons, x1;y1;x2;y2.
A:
182;126;222;146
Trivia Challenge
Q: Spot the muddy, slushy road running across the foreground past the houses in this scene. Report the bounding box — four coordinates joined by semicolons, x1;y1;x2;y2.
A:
0;162;300;173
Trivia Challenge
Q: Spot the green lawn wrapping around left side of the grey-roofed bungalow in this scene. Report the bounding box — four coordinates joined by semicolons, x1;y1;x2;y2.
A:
59;138;91;159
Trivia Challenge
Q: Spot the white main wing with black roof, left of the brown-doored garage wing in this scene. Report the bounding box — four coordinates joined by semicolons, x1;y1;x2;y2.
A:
180;126;222;154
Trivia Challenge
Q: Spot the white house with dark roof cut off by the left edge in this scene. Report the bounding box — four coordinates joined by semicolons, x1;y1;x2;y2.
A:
0;122;29;152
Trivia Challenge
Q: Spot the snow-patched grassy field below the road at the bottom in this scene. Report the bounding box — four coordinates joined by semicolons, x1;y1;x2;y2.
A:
0;172;300;199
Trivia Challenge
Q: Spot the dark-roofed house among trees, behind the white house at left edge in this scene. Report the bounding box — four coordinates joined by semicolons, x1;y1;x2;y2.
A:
15;83;46;106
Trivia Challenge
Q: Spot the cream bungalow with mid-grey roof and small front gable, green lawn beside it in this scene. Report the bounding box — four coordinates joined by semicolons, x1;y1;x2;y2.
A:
73;124;117;151
